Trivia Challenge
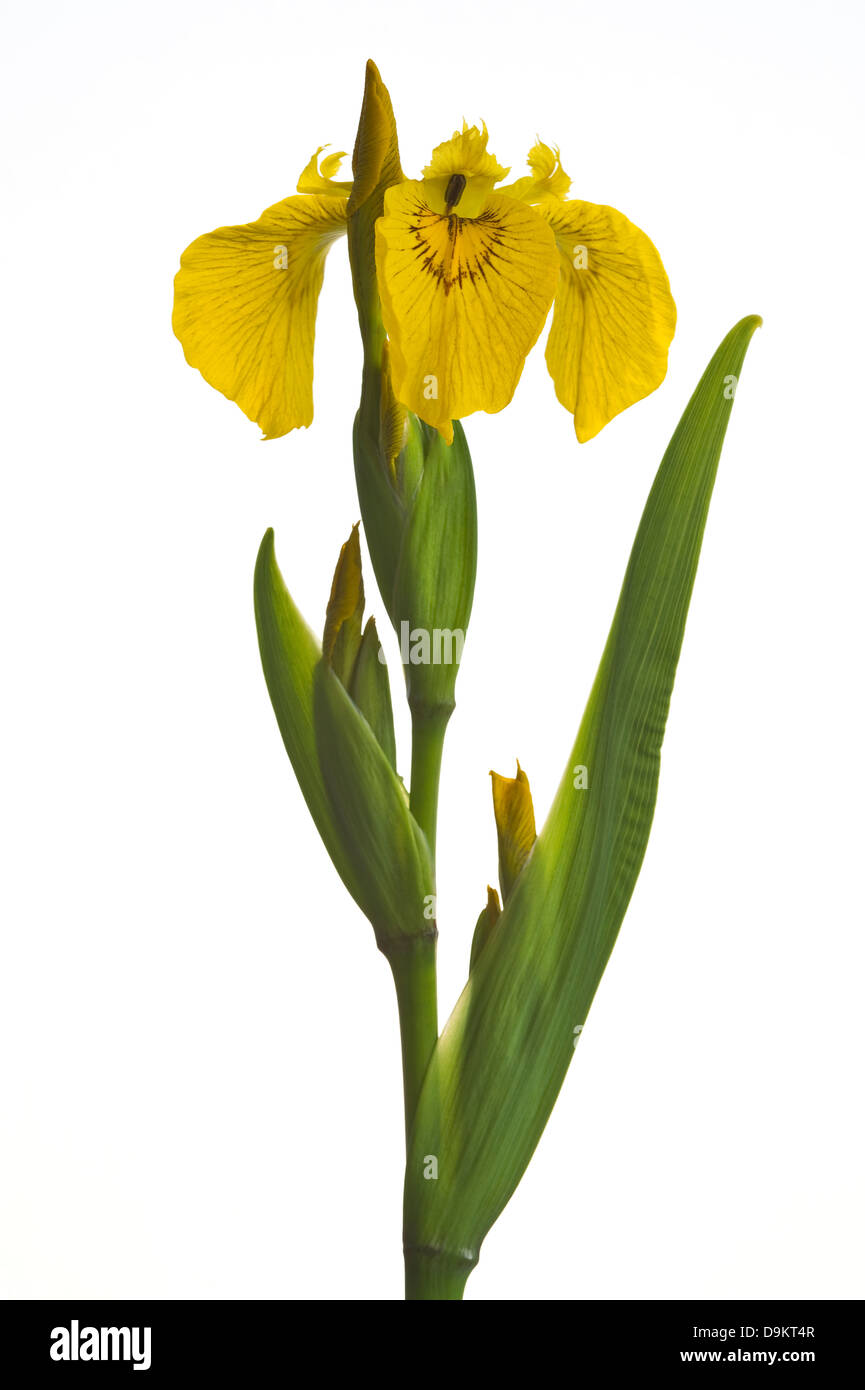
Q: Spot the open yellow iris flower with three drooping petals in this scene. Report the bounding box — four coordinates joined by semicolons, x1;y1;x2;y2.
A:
174;113;676;442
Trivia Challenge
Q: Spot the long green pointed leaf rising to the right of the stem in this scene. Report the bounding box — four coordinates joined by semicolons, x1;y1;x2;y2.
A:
405;317;759;1298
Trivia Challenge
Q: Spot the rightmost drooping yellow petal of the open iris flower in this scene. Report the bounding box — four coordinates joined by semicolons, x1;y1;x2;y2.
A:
544;202;676;443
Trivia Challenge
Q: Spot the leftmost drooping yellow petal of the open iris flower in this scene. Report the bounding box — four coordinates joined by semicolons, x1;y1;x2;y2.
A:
172;197;346;439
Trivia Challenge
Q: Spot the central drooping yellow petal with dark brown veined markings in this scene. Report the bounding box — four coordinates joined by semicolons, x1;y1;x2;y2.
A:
375;181;559;442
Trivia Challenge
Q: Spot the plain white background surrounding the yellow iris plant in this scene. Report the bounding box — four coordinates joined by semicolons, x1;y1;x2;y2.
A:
0;0;865;1300
